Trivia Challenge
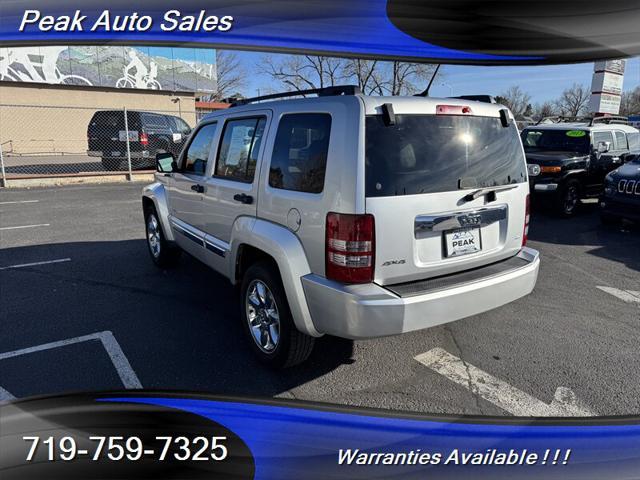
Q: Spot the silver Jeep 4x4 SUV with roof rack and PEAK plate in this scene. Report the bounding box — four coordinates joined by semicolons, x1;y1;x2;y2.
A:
143;87;539;367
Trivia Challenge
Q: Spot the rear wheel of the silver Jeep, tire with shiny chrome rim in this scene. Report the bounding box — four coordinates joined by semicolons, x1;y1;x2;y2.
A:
240;262;315;369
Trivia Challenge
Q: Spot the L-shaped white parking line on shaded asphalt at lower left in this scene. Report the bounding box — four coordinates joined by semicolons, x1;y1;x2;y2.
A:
0;330;142;390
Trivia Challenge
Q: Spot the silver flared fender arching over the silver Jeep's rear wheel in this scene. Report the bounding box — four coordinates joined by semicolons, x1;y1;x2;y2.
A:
229;217;322;337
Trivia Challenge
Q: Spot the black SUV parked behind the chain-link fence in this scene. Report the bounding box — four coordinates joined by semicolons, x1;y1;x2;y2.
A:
87;110;191;170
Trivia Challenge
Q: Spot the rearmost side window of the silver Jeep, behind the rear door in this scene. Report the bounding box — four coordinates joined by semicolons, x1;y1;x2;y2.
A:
269;113;331;193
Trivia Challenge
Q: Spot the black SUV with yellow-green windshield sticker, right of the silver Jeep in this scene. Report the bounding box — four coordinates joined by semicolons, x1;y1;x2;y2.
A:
521;117;640;217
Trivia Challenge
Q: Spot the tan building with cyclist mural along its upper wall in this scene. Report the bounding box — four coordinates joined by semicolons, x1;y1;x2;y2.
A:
0;46;220;156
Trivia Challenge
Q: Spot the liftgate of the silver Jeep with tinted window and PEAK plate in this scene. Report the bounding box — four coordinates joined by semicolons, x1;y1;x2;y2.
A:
365;106;529;284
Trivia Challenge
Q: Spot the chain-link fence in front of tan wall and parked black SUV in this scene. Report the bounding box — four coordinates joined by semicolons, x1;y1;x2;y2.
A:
0;103;196;186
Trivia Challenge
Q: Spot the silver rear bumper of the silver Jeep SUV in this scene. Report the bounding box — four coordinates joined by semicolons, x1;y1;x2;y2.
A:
302;248;540;339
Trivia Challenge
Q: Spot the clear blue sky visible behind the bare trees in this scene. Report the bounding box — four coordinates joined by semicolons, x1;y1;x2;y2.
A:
228;52;640;105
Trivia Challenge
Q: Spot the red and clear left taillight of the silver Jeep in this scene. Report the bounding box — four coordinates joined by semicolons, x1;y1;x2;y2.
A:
325;213;376;283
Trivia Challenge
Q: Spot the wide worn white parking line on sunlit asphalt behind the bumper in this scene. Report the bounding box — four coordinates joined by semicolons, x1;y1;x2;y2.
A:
415;348;595;417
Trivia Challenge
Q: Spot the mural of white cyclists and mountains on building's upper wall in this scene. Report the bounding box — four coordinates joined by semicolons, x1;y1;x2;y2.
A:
0;46;216;92
